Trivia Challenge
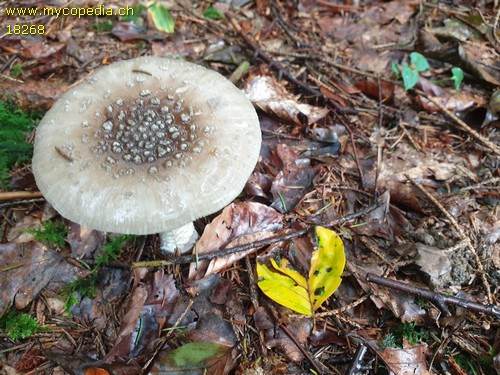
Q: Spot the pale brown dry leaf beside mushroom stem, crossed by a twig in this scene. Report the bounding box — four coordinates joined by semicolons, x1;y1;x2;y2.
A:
189;202;282;279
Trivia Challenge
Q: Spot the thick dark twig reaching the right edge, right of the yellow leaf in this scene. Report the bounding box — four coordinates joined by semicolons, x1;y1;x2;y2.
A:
366;273;500;318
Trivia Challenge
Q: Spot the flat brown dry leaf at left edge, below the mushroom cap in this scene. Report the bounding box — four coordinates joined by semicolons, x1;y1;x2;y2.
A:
0;242;63;311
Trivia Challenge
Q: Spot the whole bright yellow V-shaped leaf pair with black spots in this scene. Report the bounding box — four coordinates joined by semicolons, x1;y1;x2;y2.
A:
257;227;345;315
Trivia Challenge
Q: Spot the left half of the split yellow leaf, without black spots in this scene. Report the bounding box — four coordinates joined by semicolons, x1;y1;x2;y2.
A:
257;260;312;315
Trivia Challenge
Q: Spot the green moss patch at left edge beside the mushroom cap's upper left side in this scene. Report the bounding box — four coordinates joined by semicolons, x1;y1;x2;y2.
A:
0;100;41;188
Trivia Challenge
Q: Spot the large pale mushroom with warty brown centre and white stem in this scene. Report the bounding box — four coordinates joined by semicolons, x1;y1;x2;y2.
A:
33;57;261;252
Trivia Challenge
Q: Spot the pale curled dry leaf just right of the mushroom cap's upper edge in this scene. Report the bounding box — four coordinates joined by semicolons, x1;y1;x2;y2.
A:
245;76;328;126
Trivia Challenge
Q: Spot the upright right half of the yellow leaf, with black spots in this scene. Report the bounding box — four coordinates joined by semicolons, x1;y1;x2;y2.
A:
308;227;345;310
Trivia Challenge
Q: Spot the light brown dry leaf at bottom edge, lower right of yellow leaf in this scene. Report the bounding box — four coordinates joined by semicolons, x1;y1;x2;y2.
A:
377;343;432;375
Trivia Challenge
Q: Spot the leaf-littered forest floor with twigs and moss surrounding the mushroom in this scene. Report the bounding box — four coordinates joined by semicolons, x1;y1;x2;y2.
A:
0;0;500;375
